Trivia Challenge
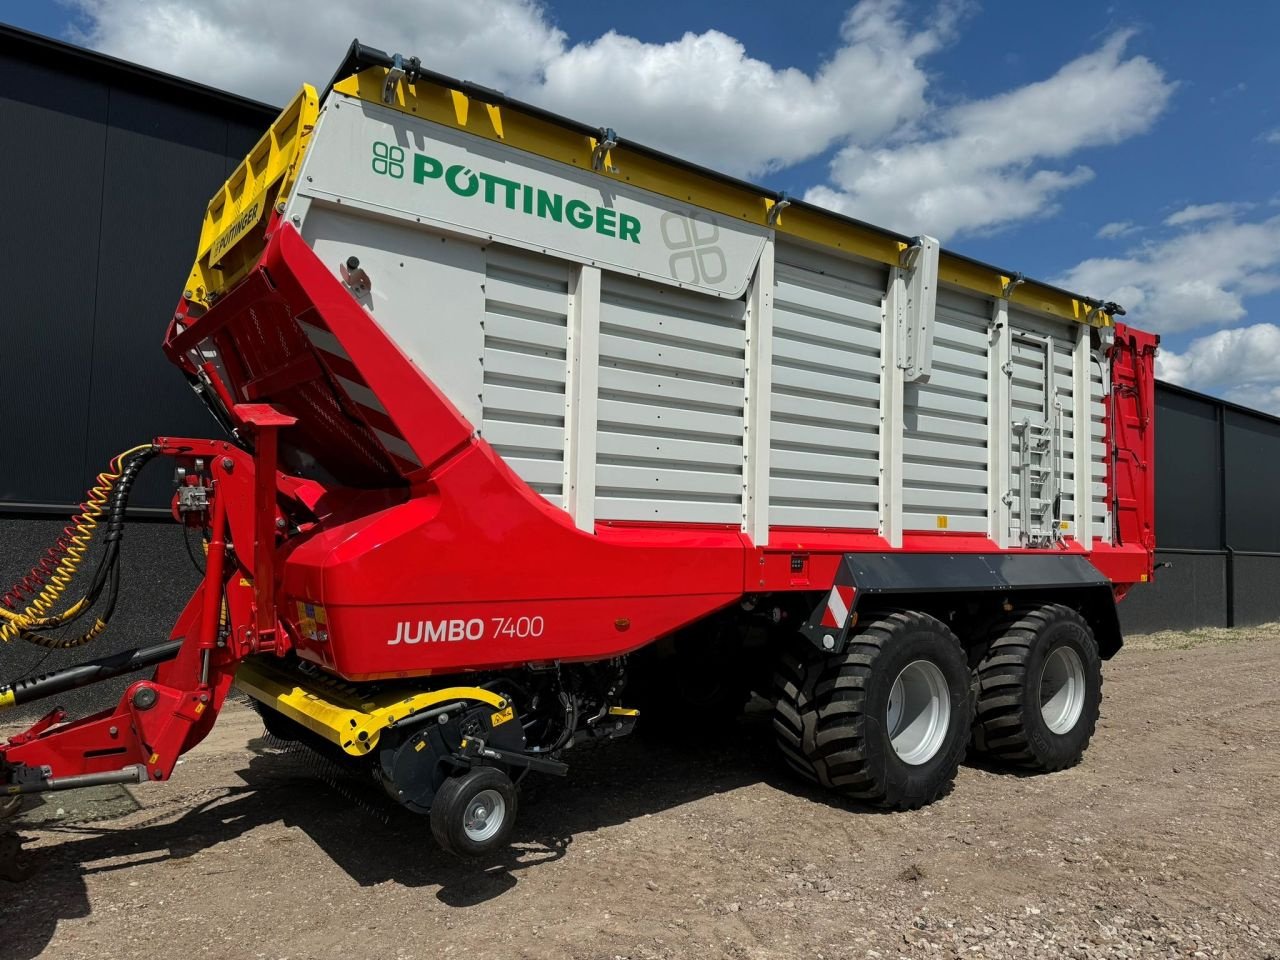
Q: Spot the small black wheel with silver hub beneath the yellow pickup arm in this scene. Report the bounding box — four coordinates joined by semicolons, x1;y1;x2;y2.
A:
431;767;517;858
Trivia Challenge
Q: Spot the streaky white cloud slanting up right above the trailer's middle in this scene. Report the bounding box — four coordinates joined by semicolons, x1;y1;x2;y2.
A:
808;33;1174;238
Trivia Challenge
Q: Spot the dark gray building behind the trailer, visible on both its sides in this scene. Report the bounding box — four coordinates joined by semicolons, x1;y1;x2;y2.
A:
0;26;1280;705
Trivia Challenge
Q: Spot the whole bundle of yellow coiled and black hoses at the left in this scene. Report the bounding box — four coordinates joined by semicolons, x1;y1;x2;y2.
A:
0;444;155;649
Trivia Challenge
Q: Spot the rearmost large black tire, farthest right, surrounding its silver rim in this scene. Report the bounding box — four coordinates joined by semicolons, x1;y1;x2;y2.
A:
973;604;1102;772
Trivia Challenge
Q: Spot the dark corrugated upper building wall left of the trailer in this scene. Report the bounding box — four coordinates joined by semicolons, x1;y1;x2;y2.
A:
0;28;275;509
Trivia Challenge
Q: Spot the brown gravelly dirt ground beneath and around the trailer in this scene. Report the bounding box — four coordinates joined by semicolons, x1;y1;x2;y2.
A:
0;627;1280;960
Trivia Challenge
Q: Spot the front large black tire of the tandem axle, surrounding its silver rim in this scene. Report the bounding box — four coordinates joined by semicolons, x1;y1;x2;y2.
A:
773;612;973;810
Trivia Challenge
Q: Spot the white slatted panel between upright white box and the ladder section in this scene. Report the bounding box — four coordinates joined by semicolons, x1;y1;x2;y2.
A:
902;287;992;534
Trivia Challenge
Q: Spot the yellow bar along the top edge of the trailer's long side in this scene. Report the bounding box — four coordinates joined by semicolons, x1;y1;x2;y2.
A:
333;67;1114;326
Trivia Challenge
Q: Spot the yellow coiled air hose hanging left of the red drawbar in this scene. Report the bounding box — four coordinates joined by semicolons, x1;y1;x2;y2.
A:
0;443;151;648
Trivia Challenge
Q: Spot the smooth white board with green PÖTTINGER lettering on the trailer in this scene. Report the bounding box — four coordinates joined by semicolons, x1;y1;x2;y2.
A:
294;93;768;298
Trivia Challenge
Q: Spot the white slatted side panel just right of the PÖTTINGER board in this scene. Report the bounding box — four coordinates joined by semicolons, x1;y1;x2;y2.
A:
769;244;888;529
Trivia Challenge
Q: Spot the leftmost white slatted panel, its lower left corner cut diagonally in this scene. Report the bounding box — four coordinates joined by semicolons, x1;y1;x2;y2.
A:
480;246;570;507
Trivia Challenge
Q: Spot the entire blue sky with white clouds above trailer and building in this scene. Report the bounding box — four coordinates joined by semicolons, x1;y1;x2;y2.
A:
10;0;1280;411
